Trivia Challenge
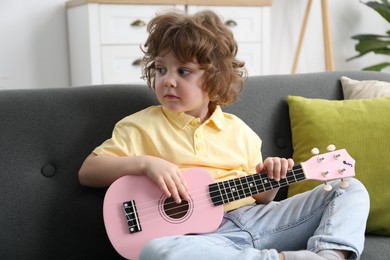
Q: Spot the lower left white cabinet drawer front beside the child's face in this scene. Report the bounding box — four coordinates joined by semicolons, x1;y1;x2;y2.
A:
102;44;145;84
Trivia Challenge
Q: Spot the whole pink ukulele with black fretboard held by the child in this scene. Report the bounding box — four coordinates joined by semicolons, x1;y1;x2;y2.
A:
103;149;355;259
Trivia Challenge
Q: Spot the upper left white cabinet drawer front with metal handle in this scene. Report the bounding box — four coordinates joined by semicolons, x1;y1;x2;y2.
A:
100;4;183;44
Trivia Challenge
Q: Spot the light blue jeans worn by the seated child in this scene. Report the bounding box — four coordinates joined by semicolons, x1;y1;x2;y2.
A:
140;179;369;260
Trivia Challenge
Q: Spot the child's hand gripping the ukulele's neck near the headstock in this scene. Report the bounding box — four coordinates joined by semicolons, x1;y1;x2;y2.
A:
256;157;294;181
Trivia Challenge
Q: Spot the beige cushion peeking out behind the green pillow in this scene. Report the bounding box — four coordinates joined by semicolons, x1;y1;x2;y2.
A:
341;76;390;99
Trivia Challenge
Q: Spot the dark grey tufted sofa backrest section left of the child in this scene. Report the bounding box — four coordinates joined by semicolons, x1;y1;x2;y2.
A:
0;86;155;259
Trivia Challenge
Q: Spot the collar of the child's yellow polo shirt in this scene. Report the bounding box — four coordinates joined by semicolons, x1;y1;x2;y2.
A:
161;106;225;130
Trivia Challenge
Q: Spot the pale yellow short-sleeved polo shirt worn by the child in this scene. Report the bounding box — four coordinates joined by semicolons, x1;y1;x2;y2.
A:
93;106;262;210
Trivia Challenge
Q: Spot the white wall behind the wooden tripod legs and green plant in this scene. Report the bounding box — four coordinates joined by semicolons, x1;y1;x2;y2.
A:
271;0;390;74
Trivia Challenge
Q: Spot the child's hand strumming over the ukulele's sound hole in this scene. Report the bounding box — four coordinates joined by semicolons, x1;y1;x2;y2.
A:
142;157;190;204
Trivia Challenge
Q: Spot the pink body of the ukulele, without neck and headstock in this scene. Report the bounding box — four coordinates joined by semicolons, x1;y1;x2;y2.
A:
103;169;224;259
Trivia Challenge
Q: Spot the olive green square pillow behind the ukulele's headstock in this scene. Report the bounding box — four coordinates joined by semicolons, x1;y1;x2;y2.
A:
287;96;390;236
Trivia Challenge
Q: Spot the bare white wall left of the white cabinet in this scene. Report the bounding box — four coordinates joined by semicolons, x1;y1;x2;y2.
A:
0;0;70;89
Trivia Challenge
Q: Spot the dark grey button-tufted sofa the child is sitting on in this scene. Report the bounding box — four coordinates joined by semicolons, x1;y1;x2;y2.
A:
0;72;390;260
